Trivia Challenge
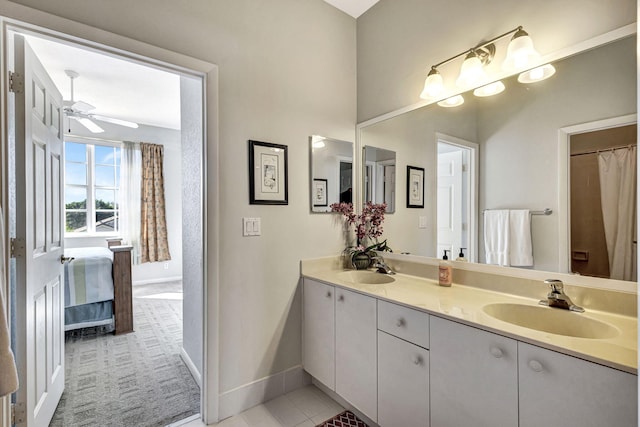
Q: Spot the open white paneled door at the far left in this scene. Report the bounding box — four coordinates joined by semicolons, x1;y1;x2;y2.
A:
9;34;64;427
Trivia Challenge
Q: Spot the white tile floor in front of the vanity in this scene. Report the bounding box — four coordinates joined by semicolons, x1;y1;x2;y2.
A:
175;385;344;427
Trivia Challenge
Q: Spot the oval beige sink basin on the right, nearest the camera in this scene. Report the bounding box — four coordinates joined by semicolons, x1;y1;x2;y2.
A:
482;303;620;339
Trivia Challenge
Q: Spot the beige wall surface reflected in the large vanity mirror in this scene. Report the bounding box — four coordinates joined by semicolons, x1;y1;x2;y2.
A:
360;34;637;280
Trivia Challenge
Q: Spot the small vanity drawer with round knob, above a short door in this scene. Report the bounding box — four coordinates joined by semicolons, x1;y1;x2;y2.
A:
378;300;429;348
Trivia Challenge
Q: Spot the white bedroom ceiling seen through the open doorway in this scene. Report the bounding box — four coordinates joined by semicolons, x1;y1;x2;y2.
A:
27;36;180;129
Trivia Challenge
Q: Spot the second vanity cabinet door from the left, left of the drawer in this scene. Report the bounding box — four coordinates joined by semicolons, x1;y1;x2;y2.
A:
335;288;378;421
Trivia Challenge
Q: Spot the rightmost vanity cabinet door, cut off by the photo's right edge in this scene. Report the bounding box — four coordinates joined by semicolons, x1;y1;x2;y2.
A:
518;343;638;427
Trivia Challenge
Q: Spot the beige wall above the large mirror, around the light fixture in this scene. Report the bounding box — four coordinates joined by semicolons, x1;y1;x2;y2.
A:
357;0;637;122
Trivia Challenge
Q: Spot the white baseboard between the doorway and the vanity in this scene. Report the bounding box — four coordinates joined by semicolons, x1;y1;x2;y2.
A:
218;365;311;421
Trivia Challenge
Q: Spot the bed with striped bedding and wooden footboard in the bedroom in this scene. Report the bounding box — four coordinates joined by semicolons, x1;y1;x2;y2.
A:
64;239;133;334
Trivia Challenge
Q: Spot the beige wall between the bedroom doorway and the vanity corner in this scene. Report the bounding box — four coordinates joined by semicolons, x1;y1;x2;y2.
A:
2;0;356;416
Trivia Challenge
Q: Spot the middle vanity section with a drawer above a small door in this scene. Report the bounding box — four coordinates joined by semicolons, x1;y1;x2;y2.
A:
378;301;429;427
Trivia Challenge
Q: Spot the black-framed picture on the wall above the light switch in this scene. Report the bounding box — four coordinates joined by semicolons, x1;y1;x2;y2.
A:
249;140;289;205
